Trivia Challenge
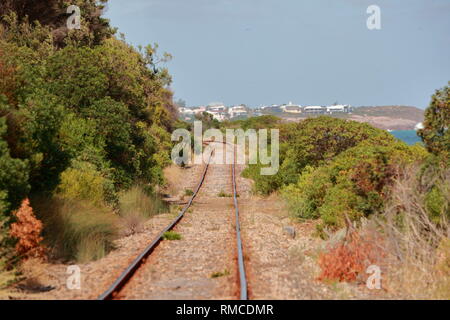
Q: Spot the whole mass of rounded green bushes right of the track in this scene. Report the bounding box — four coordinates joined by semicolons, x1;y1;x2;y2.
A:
243;117;430;230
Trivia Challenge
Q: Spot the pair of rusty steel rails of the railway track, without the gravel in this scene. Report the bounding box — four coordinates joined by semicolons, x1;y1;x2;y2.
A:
98;142;248;300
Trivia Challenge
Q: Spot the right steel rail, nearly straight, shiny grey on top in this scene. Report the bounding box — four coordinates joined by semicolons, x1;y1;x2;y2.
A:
231;146;248;300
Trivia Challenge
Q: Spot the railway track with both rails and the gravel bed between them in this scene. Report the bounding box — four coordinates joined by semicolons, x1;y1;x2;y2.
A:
98;142;248;300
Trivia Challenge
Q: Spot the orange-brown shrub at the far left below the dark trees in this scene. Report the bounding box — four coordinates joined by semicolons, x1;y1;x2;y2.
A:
10;199;45;258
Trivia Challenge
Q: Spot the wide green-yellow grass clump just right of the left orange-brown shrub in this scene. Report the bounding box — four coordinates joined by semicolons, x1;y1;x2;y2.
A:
33;197;118;262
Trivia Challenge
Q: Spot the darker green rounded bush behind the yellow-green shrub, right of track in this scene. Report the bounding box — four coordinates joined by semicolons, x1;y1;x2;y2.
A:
244;117;400;194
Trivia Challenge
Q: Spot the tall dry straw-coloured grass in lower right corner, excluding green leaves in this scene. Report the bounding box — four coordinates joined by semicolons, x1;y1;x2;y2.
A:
377;167;450;299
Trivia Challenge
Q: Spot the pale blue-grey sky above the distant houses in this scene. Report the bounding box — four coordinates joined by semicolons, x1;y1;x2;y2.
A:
105;0;450;108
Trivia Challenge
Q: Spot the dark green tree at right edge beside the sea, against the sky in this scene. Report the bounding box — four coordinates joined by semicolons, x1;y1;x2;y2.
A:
418;81;450;157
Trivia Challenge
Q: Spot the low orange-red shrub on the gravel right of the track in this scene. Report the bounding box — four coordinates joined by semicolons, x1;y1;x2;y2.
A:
318;231;384;282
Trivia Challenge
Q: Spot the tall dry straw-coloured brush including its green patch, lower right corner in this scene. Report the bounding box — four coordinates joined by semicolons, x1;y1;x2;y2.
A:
370;162;450;300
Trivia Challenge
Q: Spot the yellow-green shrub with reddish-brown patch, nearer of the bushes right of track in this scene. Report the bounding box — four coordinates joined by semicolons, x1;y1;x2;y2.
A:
281;140;427;229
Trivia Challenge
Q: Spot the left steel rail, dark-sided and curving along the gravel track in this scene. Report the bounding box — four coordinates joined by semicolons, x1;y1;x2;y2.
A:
97;152;213;300
